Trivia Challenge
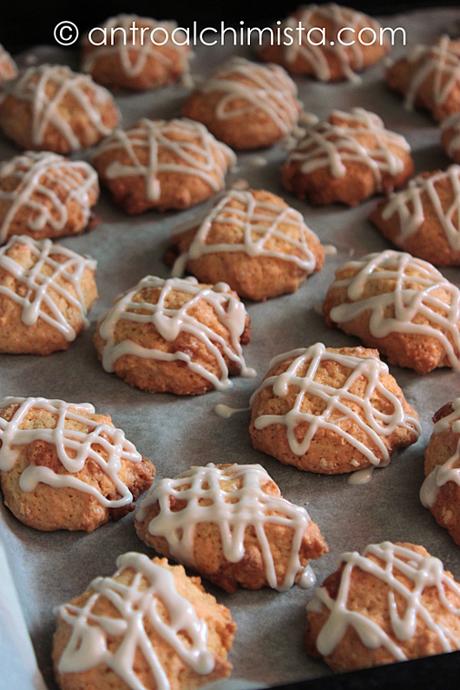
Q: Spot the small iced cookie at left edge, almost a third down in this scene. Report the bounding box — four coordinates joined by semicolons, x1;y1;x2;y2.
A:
0;151;99;243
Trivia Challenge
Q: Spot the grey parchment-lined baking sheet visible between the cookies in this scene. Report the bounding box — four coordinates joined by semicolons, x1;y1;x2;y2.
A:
0;9;460;690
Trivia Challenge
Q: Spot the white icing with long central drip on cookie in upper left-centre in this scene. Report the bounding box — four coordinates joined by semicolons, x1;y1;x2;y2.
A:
95;118;236;201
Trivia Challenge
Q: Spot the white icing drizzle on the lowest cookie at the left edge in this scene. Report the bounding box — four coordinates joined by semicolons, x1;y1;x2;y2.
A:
0;397;142;508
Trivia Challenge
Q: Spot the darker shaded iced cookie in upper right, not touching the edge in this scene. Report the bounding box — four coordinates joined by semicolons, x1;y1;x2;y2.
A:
281;108;414;206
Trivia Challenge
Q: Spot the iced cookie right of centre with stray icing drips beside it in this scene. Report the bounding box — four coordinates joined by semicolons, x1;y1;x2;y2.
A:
249;343;420;474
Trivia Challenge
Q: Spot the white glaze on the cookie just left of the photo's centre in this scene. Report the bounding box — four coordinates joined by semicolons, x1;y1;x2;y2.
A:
97;276;255;390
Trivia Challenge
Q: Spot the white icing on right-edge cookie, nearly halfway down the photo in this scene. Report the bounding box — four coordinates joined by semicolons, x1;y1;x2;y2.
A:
329;249;460;370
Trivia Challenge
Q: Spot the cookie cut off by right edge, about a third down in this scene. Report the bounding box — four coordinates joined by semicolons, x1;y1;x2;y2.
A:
370;165;460;266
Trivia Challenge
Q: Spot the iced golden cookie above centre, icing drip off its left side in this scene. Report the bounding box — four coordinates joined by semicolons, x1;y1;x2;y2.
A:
166;189;324;301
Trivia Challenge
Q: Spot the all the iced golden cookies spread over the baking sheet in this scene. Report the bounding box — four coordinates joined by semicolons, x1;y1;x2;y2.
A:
0;5;460;690
